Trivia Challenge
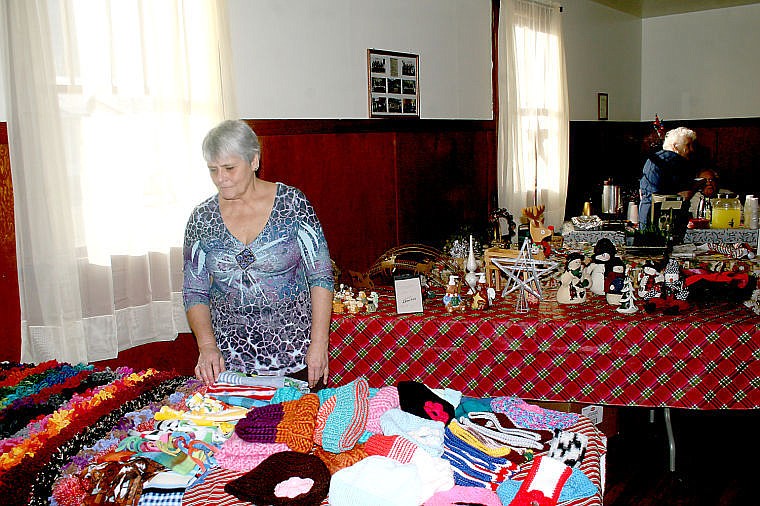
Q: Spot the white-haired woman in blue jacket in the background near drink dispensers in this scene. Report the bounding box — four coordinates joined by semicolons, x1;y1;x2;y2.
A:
639;127;697;229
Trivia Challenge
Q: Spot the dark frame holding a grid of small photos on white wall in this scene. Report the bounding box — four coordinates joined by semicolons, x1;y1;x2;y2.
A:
367;49;420;118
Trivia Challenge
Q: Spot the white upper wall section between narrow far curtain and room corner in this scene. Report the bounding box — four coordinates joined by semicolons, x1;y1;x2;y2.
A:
562;0;641;121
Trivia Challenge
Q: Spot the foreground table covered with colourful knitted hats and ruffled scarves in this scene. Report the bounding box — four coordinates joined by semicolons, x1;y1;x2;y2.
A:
0;361;606;506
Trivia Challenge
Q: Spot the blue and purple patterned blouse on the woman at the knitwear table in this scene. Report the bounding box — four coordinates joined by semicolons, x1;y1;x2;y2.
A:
183;183;333;374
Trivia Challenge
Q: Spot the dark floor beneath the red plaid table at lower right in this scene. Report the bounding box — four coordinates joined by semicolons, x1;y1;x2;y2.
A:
604;408;760;506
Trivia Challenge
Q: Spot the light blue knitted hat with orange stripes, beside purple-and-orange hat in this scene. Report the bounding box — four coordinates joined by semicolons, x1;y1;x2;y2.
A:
314;378;369;453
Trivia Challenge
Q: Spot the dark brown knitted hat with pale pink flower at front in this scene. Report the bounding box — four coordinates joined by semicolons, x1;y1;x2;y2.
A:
224;451;330;506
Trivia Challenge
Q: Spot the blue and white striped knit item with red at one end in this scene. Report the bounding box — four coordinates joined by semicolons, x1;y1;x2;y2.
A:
442;428;519;490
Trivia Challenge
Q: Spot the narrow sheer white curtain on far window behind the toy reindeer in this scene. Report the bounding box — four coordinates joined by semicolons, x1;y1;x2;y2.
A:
498;0;569;231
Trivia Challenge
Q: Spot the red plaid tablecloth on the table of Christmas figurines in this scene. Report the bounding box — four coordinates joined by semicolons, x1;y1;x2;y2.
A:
330;291;760;409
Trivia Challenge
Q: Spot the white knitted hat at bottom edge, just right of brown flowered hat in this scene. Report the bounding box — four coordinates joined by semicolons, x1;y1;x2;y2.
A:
329;455;422;506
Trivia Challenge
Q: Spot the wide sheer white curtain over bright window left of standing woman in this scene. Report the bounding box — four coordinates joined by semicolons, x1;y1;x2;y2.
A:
4;0;235;363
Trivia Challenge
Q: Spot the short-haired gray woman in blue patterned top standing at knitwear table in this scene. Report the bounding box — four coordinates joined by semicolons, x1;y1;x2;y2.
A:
183;120;333;387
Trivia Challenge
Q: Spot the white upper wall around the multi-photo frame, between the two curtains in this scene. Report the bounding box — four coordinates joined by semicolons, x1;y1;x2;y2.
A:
228;0;492;119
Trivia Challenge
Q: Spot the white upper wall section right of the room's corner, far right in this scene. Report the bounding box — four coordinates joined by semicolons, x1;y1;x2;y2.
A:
641;4;760;120
